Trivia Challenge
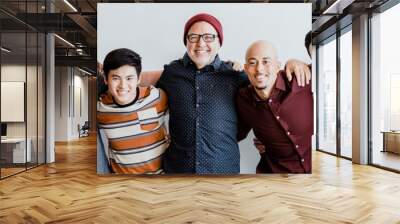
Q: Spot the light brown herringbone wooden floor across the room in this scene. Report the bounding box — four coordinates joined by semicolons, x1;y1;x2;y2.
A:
0;138;400;224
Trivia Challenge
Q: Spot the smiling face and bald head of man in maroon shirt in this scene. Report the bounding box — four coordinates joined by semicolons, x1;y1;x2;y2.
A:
244;41;279;90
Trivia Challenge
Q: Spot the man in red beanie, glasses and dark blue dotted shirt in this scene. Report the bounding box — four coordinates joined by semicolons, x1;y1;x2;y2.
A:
148;13;310;174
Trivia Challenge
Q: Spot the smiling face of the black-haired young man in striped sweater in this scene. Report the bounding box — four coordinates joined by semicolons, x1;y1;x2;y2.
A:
106;65;138;105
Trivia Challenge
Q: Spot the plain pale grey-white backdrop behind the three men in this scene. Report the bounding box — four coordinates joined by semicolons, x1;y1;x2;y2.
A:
97;3;311;173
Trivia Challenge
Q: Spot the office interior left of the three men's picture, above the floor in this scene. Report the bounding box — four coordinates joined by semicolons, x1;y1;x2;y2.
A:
0;0;96;179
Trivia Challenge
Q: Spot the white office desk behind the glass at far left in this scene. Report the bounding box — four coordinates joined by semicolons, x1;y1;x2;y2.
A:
1;138;32;163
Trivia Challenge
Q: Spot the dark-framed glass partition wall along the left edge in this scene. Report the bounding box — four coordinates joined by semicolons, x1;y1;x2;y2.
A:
0;1;46;178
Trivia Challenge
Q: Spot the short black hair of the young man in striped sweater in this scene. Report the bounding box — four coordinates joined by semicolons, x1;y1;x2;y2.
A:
103;48;142;78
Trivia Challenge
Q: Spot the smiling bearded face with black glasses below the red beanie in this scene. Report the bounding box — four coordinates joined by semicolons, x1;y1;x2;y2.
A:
186;22;220;69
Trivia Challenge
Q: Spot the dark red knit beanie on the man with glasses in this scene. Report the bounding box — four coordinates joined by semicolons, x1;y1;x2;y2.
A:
183;13;224;46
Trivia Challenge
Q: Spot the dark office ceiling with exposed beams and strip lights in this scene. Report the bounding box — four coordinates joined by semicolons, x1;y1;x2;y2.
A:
0;0;394;71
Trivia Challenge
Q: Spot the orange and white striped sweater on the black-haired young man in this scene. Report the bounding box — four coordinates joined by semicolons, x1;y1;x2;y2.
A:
97;86;169;174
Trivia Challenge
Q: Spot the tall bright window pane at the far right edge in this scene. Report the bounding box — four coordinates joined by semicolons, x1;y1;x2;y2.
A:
370;4;400;170
